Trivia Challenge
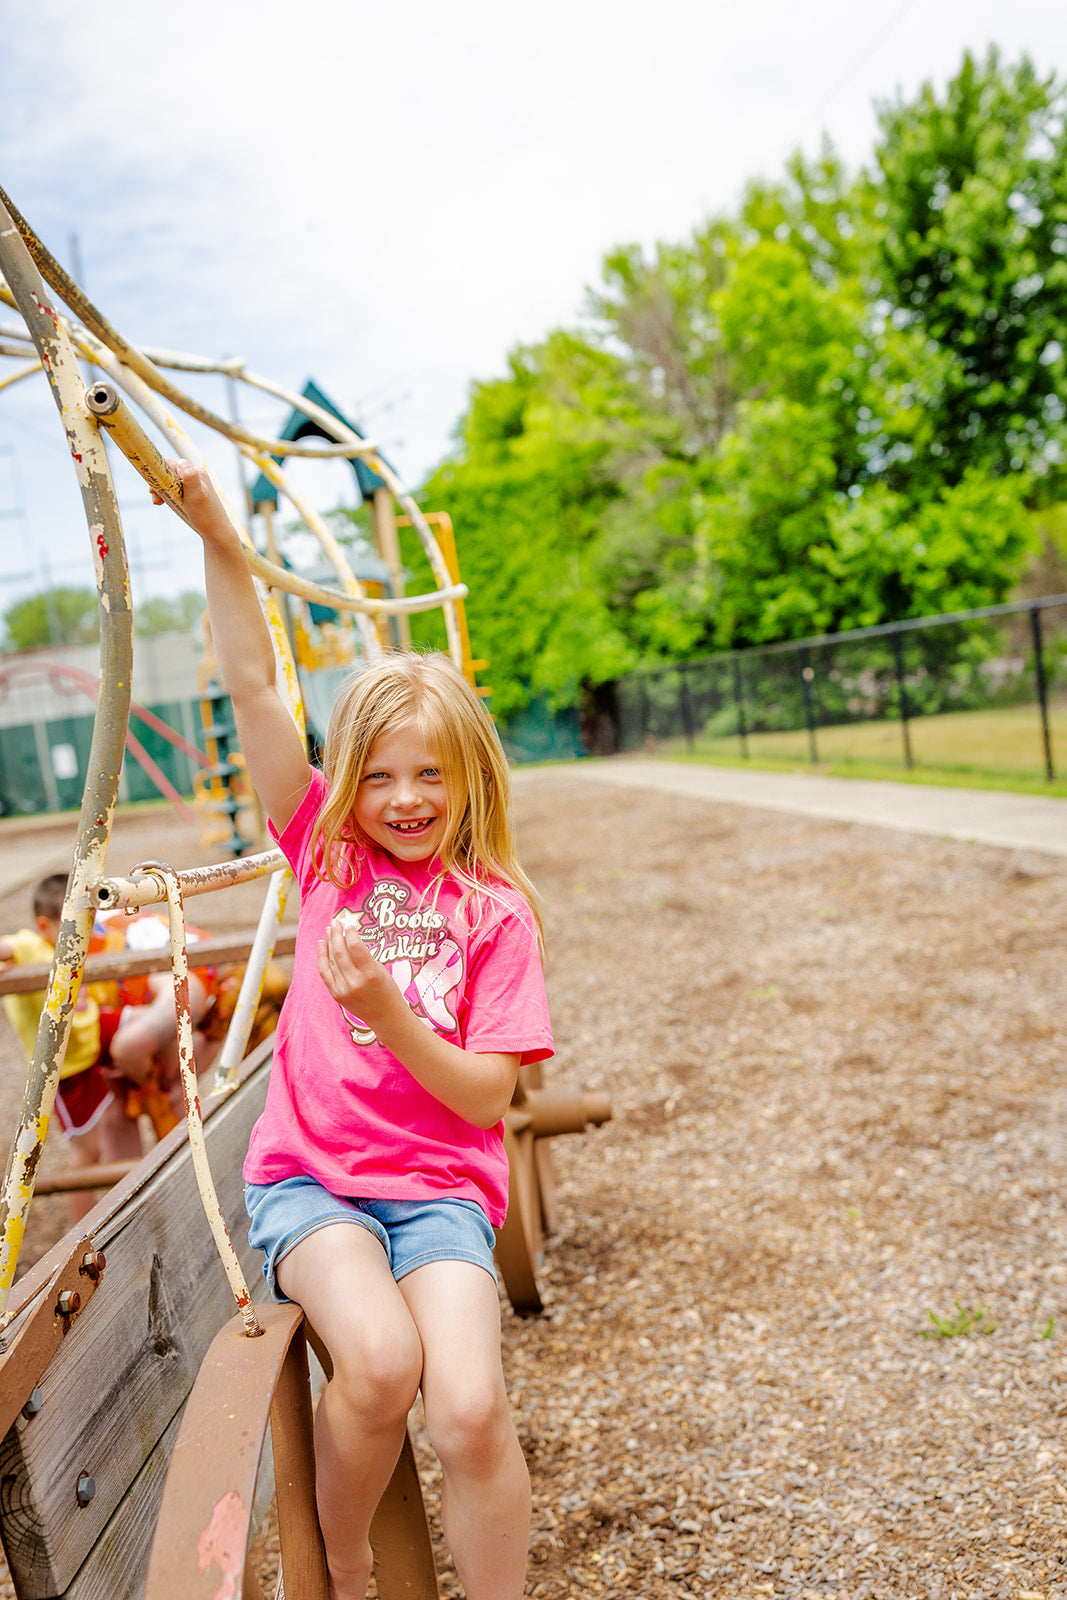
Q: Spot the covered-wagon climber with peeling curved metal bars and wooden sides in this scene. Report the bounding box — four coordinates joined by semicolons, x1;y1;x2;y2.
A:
0;178;609;1600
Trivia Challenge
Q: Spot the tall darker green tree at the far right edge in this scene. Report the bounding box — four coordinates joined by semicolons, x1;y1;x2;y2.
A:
872;50;1067;483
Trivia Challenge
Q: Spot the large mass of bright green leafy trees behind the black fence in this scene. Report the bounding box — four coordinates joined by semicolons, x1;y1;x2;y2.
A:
403;53;1067;715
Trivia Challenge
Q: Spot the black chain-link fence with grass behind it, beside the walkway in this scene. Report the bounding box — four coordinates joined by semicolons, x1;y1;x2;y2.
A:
601;595;1067;781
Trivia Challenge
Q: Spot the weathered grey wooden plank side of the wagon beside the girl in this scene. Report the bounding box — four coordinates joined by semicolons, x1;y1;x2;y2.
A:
0;1048;270;1600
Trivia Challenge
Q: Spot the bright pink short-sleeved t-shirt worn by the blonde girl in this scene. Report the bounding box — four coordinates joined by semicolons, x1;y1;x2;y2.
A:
245;771;552;1227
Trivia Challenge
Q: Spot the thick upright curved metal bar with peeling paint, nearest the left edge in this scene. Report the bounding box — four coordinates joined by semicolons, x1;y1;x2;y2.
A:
0;197;133;1314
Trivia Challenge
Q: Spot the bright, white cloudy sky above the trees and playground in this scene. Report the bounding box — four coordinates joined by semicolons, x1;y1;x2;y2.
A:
0;0;1067;611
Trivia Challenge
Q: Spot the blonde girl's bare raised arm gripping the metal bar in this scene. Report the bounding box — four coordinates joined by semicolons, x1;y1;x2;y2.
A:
163;461;310;830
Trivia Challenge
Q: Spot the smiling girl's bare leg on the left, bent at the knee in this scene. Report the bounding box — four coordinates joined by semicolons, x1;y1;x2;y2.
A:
278;1222;422;1600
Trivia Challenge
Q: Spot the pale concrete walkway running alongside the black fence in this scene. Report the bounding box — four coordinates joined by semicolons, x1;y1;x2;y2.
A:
539;755;1067;856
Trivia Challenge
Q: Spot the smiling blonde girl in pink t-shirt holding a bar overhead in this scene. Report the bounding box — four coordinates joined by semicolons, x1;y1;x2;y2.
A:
167;462;552;1600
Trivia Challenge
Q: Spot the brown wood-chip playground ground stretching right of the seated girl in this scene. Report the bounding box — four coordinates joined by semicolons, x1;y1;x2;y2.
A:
0;787;1067;1600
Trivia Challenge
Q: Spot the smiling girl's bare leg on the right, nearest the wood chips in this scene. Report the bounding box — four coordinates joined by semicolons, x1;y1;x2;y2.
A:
400;1261;530;1600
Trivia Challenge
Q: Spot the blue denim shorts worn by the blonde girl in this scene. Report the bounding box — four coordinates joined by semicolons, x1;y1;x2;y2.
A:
245;1176;496;1301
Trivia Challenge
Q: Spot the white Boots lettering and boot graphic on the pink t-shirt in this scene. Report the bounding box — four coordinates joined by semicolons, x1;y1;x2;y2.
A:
336;878;464;1045
